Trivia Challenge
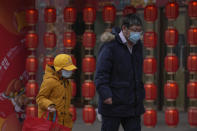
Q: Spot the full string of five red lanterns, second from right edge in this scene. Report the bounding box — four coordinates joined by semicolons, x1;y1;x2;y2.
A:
164;0;179;127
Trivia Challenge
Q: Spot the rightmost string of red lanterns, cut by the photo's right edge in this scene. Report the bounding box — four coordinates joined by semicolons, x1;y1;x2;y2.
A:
187;0;197;127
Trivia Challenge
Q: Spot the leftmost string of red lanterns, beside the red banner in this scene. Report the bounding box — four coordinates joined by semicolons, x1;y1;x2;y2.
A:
25;8;39;117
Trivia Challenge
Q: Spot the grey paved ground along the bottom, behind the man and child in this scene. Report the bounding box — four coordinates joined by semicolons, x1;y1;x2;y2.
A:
73;109;197;131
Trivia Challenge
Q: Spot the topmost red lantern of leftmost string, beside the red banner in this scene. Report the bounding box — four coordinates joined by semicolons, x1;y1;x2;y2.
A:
26;9;38;25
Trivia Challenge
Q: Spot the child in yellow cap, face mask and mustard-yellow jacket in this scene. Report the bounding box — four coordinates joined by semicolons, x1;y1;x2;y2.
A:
36;54;76;128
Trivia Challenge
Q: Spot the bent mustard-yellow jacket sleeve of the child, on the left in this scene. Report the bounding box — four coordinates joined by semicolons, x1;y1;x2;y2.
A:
36;80;54;110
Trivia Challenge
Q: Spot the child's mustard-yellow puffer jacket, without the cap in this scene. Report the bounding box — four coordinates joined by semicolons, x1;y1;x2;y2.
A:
36;66;73;128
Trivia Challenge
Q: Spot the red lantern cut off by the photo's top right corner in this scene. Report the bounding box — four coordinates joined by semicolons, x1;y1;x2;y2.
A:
188;0;197;18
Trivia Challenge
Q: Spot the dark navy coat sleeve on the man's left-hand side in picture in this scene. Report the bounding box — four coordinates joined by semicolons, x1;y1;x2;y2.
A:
95;46;112;101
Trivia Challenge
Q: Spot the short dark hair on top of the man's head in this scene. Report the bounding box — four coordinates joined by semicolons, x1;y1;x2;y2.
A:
121;14;143;28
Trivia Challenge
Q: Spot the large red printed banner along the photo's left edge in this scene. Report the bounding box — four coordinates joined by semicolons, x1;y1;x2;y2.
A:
0;0;33;131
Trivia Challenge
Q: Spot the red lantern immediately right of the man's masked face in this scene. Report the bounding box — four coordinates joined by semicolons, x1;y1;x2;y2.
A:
144;31;157;48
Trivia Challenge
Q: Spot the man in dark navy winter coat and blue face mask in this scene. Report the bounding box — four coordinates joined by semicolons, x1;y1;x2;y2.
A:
95;14;145;131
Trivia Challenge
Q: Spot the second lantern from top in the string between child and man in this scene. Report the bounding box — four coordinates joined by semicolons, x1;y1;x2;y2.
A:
83;32;96;48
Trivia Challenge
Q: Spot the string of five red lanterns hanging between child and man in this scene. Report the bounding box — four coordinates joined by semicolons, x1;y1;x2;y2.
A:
82;5;96;124
